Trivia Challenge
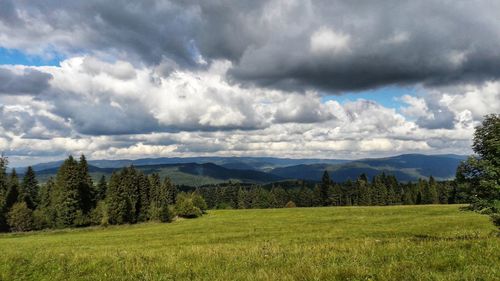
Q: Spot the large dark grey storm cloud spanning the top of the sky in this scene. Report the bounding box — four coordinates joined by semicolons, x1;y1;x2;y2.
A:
0;0;500;92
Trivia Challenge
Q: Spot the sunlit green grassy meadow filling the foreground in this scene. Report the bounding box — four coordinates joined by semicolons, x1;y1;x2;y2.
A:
0;205;500;280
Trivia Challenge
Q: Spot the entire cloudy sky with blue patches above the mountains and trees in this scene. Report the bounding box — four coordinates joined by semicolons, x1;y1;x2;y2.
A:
0;0;500;166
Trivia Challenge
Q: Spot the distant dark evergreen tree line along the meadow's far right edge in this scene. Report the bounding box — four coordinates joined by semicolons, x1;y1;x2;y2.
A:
195;171;467;209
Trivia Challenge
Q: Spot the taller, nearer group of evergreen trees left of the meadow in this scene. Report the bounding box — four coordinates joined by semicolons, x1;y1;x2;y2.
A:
0;155;207;231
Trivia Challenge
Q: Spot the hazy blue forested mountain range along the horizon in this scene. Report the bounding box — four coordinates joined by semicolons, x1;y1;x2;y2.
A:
16;154;466;186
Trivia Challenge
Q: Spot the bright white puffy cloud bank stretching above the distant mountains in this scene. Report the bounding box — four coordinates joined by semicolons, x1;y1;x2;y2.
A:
0;53;500;166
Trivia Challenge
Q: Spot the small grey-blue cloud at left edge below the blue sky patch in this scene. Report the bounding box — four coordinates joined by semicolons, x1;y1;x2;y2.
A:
0;68;52;95
